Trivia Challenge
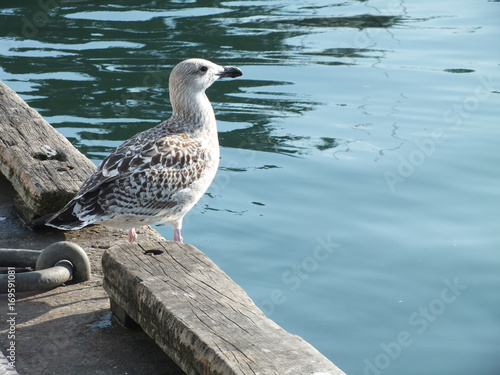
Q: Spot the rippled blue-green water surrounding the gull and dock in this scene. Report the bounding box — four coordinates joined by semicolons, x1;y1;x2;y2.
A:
0;0;500;375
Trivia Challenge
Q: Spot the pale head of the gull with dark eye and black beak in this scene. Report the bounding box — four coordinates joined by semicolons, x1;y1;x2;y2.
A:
169;59;243;94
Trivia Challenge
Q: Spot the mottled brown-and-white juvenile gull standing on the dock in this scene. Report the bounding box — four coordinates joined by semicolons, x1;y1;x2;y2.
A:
39;59;242;242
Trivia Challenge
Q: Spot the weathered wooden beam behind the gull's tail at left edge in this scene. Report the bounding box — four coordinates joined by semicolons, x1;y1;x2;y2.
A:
0;82;95;219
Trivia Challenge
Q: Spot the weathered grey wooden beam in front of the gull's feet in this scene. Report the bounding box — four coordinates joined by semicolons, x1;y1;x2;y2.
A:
102;241;343;375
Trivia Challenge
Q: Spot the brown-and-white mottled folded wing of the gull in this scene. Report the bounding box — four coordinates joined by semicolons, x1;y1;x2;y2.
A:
47;133;207;229
